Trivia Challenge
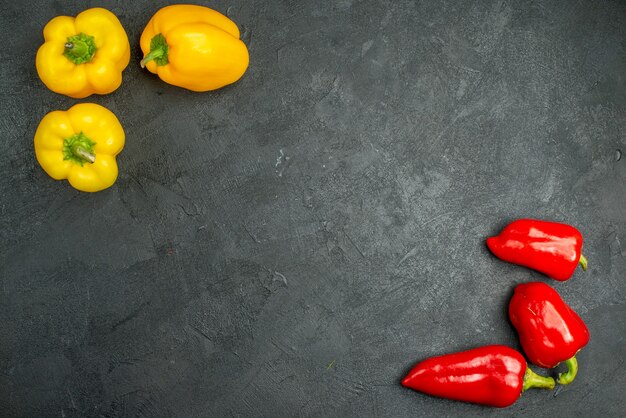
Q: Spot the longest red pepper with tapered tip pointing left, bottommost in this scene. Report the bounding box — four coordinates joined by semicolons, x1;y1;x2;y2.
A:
402;345;554;408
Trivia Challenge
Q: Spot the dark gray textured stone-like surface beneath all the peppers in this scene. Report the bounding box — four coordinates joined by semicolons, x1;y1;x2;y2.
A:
0;0;626;417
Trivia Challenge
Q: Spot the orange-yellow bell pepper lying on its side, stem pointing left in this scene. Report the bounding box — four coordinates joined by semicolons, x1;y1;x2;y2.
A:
139;4;249;91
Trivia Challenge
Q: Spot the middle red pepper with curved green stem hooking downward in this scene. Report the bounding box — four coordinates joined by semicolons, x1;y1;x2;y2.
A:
509;282;589;385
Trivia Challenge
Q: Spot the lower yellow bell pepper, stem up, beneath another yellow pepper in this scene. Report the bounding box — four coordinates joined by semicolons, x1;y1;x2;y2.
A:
35;103;125;192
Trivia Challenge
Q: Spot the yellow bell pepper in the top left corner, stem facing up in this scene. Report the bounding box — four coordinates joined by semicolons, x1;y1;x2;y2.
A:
36;8;130;99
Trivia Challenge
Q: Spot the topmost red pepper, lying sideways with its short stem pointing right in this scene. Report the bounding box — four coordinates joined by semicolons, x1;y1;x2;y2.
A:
487;219;587;281
